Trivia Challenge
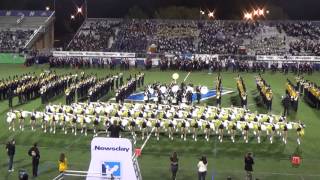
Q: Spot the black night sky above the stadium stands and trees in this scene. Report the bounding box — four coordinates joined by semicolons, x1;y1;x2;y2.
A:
0;0;320;44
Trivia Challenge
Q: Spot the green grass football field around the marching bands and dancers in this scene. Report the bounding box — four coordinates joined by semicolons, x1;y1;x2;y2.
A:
0;64;320;180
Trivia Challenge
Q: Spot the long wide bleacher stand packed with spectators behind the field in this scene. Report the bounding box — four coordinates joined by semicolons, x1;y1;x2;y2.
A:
67;18;320;55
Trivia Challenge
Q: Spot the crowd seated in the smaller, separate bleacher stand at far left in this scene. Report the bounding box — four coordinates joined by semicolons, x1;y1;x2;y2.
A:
0;29;33;52
